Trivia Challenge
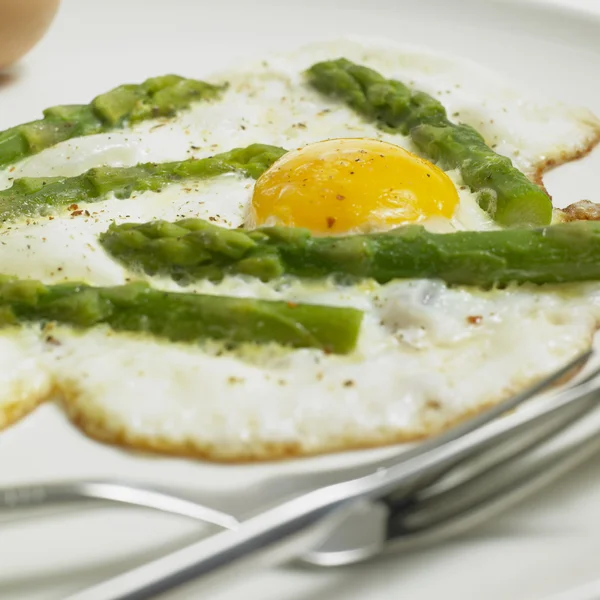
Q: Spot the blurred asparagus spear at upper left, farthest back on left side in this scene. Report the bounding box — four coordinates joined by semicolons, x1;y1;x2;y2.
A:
0;75;223;167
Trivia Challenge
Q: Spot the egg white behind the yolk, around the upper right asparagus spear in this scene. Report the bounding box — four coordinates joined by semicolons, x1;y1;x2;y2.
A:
0;38;600;227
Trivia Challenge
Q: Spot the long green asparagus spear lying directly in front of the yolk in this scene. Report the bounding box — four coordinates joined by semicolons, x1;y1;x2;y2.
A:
100;219;600;287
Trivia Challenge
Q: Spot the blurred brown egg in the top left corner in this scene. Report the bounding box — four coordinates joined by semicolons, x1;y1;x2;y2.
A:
0;0;60;69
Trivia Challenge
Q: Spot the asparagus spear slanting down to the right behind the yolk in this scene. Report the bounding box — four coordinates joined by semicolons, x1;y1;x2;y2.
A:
307;58;552;226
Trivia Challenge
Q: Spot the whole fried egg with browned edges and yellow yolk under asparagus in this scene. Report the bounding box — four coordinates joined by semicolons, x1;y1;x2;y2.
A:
0;40;600;461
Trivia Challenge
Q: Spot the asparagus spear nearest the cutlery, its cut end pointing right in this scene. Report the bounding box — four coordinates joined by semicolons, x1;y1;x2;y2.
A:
0;276;362;354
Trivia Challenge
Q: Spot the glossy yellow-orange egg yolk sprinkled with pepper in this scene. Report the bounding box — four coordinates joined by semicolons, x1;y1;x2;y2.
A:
250;138;458;234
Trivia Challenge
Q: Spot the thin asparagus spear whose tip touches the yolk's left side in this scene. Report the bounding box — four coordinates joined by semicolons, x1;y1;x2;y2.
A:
0;144;285;221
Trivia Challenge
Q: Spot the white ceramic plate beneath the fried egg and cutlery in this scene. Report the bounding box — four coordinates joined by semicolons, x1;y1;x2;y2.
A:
0;0;600;600
